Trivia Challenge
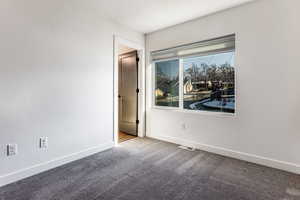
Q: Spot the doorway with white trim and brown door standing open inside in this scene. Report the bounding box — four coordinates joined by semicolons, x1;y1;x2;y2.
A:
114;37;145;145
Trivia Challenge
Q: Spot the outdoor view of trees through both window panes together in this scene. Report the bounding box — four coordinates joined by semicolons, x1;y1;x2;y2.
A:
155;51;235;113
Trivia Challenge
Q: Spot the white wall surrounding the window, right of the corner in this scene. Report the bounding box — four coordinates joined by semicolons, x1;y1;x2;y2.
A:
146;0;300;173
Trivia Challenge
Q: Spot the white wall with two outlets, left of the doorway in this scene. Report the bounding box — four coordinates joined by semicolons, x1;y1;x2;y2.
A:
0;0;144;185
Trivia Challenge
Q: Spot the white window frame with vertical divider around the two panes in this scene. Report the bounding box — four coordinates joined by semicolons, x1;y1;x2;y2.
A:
151;48;237;117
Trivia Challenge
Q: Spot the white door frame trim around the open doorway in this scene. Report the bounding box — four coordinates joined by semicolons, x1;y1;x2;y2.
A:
113;35;146;145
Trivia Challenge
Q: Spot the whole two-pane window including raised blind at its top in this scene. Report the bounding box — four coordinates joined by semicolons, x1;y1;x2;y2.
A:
151;35;235;113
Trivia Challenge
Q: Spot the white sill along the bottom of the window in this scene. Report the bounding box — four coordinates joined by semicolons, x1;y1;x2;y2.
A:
151;106;236;117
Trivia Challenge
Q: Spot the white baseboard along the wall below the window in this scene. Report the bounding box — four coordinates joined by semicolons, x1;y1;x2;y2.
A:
147;135;300;174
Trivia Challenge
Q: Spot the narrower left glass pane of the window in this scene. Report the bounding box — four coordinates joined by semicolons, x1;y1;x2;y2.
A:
154;60;179;107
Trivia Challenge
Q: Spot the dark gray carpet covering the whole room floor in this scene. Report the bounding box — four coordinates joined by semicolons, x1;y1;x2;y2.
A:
0;138;300;200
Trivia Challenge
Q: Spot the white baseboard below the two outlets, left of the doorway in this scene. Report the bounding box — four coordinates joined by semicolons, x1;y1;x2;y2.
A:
0;142;114;187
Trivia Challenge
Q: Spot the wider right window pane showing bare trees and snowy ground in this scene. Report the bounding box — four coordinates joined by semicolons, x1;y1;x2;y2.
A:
183;52;235;113
